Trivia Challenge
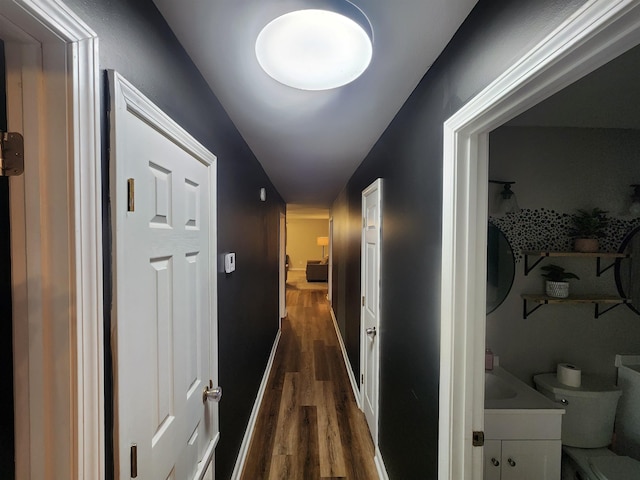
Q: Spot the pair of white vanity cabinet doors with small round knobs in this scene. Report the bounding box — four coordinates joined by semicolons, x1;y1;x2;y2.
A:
484;440;562;480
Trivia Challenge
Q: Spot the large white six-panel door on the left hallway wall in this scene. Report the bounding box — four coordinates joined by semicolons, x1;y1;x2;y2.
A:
110;72;219;480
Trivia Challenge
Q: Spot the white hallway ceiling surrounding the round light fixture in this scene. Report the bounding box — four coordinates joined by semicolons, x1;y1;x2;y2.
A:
154;0;477;206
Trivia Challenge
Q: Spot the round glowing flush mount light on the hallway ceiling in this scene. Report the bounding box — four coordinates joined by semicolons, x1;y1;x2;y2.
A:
256;0;373;90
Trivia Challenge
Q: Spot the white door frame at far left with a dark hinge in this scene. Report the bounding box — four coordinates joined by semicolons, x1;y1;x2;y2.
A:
1;0;104;479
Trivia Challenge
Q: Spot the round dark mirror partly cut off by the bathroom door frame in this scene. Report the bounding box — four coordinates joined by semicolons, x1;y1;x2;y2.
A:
487;223;516;314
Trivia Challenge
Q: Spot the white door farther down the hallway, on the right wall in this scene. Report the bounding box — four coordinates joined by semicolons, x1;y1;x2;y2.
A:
360;179;382;445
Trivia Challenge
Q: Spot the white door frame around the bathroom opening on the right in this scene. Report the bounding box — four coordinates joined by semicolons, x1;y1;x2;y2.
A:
438;0;640;480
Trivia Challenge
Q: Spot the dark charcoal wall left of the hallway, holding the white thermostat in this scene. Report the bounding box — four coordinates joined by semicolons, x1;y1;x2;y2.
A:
66;0;284;479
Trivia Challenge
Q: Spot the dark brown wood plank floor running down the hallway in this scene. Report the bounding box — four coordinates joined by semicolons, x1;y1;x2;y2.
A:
242;288;378;480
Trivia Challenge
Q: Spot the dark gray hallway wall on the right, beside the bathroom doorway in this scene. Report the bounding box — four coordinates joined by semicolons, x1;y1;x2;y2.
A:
332;0;584;479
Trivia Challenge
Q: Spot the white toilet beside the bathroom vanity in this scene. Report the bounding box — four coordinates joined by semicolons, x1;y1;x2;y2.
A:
533;366;640;480
